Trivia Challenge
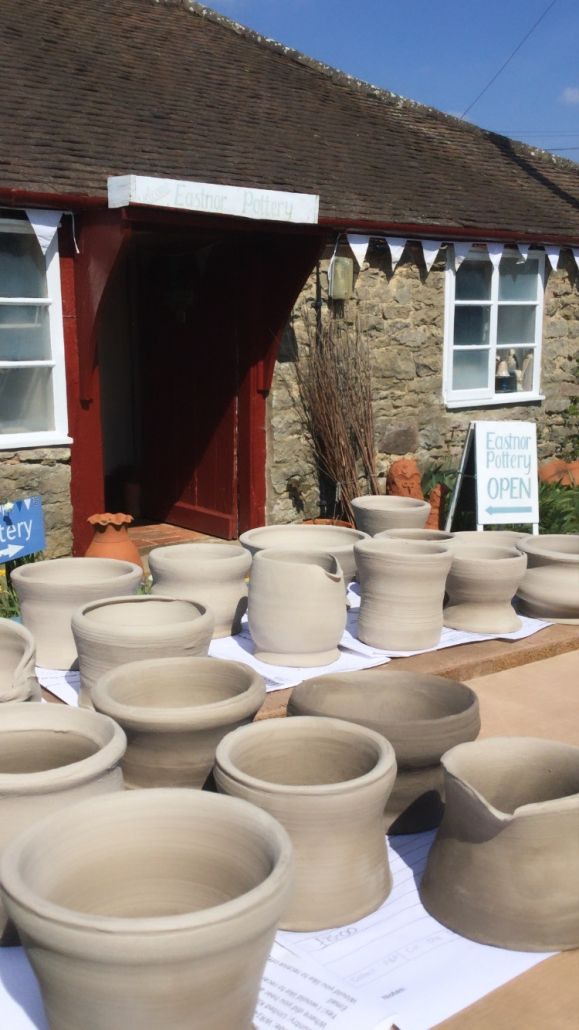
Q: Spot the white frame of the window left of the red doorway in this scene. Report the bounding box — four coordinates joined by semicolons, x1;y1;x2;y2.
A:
0;218;72;451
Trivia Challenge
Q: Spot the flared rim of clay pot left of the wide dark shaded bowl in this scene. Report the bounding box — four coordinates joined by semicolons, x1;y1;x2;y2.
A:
91;656;266;733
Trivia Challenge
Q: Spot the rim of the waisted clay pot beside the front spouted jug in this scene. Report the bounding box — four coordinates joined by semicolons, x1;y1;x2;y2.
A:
215;715;397;797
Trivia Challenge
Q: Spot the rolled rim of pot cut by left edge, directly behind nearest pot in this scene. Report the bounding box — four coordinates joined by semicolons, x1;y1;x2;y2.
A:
0;701;127;795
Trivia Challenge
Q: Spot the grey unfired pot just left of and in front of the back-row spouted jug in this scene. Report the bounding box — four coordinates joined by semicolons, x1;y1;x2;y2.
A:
72;597;213;708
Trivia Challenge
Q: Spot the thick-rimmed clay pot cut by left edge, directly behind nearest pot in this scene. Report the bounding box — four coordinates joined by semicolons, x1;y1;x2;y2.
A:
0;703;127;945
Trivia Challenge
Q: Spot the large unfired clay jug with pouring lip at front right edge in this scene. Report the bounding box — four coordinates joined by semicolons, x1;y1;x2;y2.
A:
420;736;579;952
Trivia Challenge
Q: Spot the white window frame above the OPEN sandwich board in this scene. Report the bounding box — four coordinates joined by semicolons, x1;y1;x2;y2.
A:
443;246;545;409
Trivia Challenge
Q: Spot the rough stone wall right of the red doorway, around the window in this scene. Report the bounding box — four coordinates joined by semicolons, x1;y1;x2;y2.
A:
268;237;579;522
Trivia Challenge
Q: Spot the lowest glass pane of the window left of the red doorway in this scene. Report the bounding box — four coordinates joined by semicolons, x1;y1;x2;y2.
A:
0;369;55;433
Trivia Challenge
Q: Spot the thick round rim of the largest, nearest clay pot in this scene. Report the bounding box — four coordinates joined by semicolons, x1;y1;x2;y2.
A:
0;787;293;939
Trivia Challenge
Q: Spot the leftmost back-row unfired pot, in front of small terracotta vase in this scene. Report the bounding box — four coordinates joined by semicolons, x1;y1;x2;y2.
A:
10;558;143;668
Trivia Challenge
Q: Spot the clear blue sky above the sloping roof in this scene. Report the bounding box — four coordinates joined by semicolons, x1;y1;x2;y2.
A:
207;0;579;162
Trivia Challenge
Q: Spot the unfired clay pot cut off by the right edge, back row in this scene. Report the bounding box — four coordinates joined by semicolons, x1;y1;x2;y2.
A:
517;534;579;625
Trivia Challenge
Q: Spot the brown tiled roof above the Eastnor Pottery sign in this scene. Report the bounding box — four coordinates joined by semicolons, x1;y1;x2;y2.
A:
0;0;579;241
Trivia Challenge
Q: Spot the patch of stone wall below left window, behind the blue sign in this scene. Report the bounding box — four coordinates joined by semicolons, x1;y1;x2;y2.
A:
0;447;72;558
